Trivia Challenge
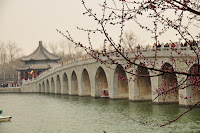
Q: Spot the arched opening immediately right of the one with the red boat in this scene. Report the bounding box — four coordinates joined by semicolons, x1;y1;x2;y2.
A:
113;65;129;98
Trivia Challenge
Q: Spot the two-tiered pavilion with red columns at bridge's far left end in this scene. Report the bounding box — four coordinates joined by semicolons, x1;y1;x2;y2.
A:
17;41;60;80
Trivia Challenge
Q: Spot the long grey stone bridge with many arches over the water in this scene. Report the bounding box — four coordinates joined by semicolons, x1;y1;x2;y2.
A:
21;47;200;105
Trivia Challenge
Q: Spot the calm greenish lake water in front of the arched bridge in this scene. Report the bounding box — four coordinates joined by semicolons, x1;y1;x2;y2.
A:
0;93;200;133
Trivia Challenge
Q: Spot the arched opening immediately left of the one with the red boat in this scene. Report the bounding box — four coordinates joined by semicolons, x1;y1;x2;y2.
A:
81;69;91;96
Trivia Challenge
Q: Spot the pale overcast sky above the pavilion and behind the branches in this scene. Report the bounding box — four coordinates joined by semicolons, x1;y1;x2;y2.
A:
0;0;198;55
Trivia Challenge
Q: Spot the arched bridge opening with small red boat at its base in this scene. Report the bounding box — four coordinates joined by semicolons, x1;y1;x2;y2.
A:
95;67;109;96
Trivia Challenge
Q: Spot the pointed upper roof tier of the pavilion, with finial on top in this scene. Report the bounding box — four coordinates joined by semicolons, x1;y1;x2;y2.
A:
21;41;60;62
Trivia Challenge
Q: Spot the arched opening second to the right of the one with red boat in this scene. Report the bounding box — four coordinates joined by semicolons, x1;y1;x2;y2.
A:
135;63;152;100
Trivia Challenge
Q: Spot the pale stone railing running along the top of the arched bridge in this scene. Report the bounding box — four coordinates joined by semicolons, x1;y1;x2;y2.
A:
24;42;200;83
